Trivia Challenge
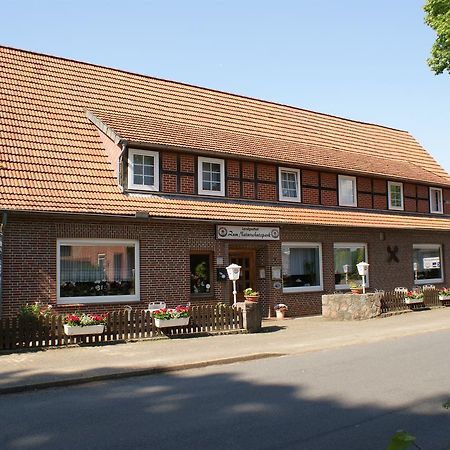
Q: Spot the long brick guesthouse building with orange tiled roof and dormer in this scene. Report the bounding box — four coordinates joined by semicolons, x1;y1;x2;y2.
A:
0;47;450;317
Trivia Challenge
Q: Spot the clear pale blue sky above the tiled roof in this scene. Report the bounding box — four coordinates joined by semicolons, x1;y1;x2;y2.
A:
0;0;450;172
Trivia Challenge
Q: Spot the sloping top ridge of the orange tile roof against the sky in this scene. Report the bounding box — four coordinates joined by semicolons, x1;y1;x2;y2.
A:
0;45;411;135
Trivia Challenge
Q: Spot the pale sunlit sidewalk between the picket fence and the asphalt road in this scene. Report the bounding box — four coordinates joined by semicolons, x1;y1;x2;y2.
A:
0;308;450;394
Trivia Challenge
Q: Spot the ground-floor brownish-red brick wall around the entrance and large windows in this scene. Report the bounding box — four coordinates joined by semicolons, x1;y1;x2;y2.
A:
2;215;450;317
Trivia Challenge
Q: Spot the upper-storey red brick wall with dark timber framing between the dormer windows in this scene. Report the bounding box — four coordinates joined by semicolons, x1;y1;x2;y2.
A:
152;151;442;214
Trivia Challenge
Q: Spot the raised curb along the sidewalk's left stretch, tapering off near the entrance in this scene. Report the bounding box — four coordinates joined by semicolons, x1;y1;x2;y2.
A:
0;353;286;395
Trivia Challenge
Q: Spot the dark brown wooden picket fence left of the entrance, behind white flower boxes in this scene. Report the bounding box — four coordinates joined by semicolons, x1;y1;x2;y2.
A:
0;305;244;350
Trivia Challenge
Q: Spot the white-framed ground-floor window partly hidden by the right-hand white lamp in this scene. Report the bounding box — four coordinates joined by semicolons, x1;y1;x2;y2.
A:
334;243;369;289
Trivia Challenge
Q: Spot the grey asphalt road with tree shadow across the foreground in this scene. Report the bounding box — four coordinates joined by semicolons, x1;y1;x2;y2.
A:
0;332;450;450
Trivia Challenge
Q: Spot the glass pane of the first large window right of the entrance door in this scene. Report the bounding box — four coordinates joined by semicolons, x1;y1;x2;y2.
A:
282;246;321;288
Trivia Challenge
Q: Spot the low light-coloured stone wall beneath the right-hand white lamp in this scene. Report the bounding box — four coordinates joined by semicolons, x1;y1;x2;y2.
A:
322;293;382;320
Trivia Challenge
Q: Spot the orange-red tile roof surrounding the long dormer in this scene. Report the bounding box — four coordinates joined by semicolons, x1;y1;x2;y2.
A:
0;47;450;230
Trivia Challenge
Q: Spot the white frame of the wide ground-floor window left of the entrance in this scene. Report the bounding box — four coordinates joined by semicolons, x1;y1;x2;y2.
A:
56;239;140;305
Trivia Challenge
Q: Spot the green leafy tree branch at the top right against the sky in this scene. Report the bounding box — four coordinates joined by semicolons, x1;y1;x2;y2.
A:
423;0;450;75
